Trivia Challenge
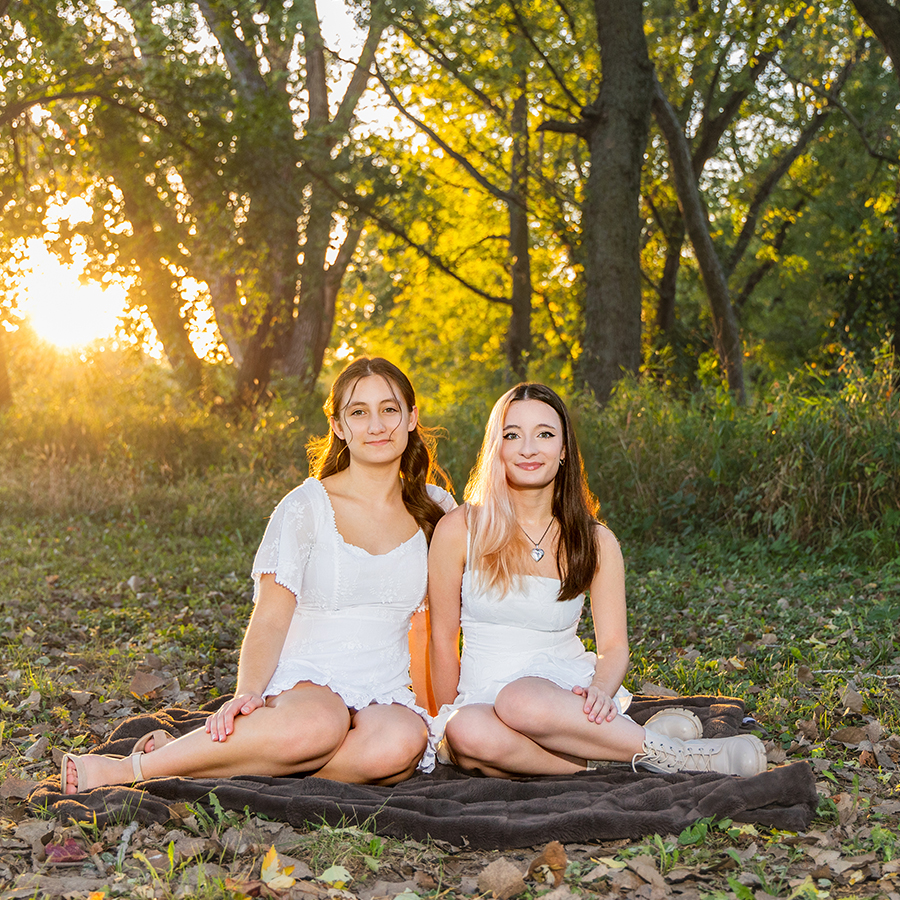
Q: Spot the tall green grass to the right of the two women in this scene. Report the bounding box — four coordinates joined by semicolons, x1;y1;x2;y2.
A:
580;353;900;552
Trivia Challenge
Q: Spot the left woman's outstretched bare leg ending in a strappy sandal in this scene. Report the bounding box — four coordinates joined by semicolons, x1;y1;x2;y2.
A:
66;682;350;793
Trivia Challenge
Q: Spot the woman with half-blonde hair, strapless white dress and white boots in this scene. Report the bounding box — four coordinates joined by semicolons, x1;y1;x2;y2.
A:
428;383;766;777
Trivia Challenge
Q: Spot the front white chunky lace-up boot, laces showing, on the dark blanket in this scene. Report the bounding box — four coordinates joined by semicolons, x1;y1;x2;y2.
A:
631;729;766;778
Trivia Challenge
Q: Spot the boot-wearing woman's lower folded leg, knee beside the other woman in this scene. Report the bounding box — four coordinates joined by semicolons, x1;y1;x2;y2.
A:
446;703;584;778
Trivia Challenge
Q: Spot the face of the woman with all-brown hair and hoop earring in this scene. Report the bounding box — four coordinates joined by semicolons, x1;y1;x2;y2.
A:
331;375;419;462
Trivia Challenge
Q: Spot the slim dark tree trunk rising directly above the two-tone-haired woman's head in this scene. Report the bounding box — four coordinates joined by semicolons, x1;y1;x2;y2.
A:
506;82;532;381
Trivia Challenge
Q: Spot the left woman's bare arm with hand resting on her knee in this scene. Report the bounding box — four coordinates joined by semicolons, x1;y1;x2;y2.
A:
206;574;297;741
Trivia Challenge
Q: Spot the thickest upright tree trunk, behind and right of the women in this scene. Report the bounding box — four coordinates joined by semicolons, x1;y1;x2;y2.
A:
578;0;653;403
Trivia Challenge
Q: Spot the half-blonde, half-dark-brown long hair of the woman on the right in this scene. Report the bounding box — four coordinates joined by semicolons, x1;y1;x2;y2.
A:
465;382;600;600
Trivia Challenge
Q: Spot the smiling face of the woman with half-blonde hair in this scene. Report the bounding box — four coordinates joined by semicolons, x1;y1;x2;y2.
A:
500;400;565;488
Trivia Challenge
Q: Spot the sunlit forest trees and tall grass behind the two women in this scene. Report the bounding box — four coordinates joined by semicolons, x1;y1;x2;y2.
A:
0;0;900;553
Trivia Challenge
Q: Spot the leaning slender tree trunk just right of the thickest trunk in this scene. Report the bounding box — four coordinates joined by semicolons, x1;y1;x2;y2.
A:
653;82;746;403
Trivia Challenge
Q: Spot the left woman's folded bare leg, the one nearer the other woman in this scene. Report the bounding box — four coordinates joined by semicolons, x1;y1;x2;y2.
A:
316;703;428;784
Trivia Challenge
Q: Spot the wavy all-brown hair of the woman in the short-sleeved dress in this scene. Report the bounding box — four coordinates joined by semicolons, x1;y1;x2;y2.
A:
306;356;451;543
